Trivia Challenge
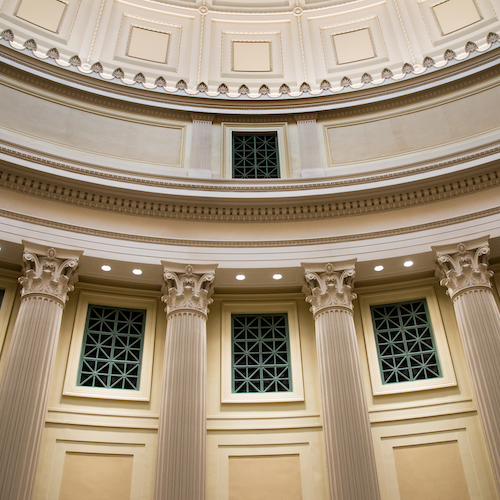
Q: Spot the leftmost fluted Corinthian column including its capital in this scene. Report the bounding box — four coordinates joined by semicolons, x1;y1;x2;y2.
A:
0;242;82;500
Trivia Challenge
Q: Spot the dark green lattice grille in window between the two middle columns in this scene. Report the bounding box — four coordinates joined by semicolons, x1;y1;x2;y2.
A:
231;314;292;393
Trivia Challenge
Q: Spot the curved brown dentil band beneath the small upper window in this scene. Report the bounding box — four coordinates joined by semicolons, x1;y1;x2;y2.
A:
0;160;500;223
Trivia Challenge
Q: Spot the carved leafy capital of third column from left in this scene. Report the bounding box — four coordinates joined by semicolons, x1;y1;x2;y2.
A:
302;260;356;316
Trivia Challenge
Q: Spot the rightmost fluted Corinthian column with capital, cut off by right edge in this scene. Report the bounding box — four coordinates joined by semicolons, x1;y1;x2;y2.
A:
433;238;500;493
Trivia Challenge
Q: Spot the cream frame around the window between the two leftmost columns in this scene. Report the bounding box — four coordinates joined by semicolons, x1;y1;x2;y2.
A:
63;290;157;401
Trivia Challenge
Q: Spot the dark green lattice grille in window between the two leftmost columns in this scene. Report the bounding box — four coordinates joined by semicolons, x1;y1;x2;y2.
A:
78;305;146;390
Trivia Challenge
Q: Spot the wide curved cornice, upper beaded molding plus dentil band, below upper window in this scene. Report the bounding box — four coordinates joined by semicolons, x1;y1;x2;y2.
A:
0;147;500;222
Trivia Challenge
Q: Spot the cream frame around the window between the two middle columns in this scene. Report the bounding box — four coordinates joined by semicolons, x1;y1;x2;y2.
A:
221;301;304;403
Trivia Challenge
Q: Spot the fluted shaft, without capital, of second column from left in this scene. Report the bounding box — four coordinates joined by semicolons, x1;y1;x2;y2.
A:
156;311;207;500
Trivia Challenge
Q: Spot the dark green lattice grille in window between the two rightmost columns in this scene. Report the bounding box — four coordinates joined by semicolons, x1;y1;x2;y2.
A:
371;299;442;384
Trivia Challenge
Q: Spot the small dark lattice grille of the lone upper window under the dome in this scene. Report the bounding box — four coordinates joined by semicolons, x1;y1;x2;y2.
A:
233;132;280;179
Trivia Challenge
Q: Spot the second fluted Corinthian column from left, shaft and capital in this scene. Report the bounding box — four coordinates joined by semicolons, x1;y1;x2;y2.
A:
155;262;217;500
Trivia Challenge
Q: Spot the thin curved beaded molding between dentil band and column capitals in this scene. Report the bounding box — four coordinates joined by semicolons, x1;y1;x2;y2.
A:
0;207;500;248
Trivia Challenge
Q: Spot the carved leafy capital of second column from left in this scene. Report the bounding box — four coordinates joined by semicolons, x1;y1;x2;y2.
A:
161;261;217;317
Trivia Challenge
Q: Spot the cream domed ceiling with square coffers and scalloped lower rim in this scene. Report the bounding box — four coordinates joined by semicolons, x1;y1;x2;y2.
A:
0;0;500;100
